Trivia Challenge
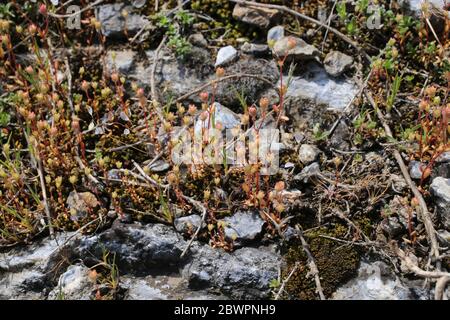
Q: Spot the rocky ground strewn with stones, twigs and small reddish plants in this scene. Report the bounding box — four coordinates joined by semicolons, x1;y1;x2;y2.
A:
0;0;450;300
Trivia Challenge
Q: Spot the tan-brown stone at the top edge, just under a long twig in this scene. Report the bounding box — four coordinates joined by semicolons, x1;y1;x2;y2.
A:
233;4;280;29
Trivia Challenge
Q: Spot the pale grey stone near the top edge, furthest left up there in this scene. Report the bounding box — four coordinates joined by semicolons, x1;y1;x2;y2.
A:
96;3;149;38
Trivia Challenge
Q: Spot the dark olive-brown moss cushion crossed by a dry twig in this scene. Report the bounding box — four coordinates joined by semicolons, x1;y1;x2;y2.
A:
283;225;360;300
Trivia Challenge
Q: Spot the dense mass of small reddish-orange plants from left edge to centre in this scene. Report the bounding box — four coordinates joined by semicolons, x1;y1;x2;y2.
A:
0;0;295;249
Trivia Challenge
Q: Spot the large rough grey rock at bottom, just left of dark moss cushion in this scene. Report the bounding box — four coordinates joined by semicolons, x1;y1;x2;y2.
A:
182;246;282;299
